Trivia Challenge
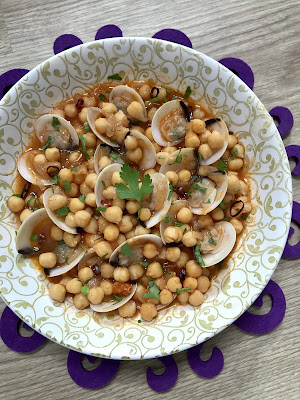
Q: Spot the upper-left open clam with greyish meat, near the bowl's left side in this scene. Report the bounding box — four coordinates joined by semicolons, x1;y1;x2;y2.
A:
35;114;79;150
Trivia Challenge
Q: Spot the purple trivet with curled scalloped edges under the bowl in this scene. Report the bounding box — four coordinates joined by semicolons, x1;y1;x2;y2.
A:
0;25;292;392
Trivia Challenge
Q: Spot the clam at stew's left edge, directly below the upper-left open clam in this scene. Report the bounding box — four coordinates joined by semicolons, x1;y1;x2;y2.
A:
18;150;61;187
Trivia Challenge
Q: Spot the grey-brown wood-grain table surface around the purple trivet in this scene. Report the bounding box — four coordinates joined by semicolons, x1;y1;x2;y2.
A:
0;0;300;400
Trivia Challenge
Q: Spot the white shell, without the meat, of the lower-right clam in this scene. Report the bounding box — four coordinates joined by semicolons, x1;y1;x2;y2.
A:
194;221;236;268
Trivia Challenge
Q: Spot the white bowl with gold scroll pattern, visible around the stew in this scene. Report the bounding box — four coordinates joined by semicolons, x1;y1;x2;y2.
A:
0;38;292;359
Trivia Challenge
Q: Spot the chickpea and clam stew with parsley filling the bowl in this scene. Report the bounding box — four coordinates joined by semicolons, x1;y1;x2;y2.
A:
8;80;252;321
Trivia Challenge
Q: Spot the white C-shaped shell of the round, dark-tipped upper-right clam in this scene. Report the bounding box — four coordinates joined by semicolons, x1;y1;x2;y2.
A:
151;100;185;146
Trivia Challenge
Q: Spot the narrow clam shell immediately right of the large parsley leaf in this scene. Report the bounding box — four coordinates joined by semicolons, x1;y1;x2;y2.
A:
145;172;172;228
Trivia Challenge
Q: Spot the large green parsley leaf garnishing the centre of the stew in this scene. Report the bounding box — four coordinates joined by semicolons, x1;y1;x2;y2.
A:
116;164;154;211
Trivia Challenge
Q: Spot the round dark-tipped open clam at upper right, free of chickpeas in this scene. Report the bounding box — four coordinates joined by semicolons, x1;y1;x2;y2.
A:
151;100;190;146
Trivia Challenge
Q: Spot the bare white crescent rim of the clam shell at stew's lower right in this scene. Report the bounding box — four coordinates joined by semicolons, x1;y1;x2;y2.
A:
200;221;236;268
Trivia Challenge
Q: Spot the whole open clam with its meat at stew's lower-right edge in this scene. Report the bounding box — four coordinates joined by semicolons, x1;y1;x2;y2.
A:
194;221;236;267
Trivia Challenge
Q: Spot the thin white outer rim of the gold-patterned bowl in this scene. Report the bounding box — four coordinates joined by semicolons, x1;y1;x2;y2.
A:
0;36;293;360
